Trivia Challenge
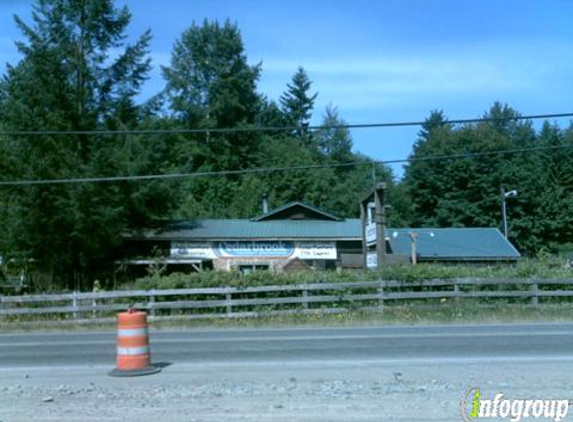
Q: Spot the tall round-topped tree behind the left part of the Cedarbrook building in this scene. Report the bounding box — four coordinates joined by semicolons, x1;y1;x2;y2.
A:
162;20;268;221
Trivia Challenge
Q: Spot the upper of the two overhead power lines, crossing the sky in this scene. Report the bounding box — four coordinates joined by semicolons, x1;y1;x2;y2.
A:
0;112;573;136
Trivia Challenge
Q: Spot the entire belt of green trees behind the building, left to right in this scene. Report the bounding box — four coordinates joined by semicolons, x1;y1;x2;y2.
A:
0;0;573;287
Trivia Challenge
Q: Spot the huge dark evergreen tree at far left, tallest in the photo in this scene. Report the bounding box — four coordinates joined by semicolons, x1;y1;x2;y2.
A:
0;0;168;288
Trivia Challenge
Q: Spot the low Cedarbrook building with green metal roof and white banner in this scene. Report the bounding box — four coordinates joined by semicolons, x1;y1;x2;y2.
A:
119;202;520;272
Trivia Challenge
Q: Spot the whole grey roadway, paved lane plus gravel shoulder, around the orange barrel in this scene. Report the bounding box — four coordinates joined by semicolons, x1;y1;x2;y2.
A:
0;324;573;422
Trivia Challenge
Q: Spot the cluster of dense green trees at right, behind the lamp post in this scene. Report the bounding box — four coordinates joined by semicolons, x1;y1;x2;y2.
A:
404;103;573;255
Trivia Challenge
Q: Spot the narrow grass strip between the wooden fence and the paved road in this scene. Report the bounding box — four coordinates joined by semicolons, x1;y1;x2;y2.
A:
0;300;573;332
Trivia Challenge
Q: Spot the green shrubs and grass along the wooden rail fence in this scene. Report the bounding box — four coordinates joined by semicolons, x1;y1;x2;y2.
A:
0;256;573;330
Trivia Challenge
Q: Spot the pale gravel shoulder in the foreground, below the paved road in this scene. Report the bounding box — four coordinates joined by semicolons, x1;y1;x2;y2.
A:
0;360;573;422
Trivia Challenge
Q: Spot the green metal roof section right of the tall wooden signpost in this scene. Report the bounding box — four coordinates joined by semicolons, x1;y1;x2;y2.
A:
386;228;521;260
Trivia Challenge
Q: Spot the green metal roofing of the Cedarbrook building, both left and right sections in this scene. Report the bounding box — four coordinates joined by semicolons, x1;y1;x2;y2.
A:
129;218;521;260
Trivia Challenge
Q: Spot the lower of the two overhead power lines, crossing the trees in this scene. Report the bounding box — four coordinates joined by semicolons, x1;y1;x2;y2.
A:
0;144;573;187
